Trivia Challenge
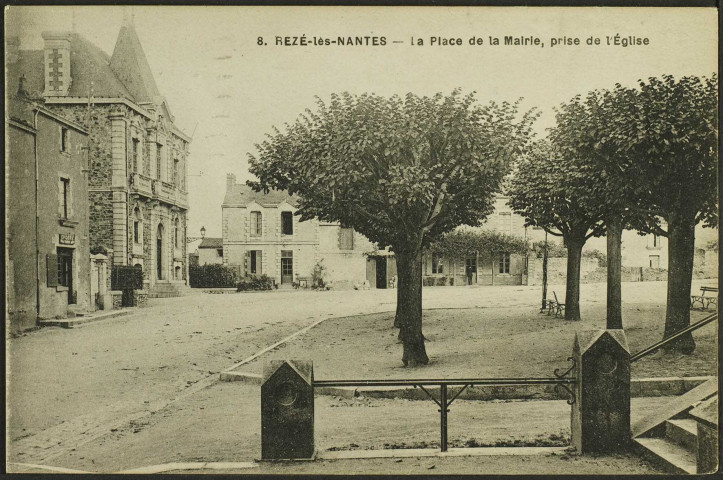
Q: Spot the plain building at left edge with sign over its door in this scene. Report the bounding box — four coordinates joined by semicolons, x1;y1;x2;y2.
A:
5;92;93;331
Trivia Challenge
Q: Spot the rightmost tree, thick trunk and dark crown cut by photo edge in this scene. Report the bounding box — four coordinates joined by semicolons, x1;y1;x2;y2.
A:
603;74;718;353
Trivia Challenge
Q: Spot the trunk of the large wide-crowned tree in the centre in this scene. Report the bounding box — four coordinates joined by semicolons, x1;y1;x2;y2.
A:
395;248;429;367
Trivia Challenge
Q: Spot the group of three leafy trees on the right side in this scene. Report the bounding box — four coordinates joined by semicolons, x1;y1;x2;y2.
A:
509;75;718;353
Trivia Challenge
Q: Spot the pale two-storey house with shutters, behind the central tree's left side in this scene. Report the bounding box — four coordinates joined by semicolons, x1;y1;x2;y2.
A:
221;174;375;288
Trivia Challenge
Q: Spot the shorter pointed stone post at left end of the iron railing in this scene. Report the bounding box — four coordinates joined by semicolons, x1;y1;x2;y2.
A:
261;360;314;460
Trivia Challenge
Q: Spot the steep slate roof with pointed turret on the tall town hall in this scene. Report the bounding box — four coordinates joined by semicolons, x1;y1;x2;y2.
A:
7;23;159;103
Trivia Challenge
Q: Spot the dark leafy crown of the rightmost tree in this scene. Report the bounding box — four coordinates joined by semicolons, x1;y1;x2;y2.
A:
598;74;718;236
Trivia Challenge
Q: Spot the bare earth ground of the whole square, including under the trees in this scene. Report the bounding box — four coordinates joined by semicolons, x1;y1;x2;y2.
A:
8;282;717;473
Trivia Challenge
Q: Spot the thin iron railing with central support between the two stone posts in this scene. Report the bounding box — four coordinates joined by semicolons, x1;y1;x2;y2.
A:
312;357;576;452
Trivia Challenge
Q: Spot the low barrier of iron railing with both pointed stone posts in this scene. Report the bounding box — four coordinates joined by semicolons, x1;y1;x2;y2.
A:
261;330;630;460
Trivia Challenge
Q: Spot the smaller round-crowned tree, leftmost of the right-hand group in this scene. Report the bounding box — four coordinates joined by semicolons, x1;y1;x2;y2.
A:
509;142;605;320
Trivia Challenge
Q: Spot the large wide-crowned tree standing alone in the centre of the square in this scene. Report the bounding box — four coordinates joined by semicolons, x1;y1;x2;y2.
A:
249;90;536;366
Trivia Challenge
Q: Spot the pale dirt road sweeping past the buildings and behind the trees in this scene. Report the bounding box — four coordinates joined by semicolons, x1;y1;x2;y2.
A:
7;283;700;463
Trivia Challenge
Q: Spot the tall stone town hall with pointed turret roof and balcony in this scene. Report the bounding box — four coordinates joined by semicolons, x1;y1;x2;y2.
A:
8;18;190;296
